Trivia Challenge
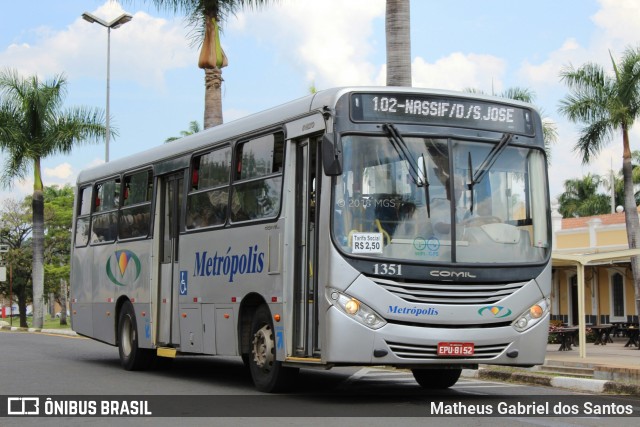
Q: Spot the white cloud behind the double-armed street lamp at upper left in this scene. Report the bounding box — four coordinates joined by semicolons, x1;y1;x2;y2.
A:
0;2;197;86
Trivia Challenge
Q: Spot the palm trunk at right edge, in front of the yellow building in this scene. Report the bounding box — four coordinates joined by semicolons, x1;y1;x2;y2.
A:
622;126;640;322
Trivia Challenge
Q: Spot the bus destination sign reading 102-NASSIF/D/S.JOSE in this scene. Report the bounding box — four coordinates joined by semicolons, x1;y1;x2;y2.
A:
351;93;534;135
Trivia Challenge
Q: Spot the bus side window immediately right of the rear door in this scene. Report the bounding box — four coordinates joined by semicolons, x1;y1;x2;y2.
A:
186;147;231;229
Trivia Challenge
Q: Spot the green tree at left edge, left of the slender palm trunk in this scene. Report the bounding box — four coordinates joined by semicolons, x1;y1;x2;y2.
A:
0;199;33;328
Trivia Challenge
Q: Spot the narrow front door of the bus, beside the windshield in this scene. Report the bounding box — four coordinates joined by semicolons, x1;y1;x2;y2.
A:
294;139;320;358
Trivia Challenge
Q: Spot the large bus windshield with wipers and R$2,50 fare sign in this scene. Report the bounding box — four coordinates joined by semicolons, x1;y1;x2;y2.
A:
333;135;551;264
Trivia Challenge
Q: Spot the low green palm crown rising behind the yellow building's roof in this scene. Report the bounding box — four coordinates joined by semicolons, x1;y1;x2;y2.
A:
558;174;611;218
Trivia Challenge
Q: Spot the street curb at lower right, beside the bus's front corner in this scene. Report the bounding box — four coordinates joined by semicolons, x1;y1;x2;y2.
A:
462;368;640;396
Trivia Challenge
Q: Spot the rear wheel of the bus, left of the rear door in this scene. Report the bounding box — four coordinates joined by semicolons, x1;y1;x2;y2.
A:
118;301;155;371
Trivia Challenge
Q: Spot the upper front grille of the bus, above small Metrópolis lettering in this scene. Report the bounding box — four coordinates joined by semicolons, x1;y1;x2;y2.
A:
369;277;526;305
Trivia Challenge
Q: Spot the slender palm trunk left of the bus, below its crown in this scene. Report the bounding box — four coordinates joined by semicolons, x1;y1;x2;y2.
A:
31;159;44;328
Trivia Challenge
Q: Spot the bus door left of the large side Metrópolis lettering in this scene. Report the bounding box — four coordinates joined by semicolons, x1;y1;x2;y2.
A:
156;172;184;346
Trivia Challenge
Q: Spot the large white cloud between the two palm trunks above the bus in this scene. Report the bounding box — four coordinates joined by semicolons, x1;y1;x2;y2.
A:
228;0;385;87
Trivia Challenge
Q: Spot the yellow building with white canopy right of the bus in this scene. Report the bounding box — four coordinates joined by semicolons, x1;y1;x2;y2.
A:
551;206;638;325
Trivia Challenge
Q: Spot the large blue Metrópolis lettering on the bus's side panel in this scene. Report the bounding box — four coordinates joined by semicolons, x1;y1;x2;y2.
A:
193;245;264;283
